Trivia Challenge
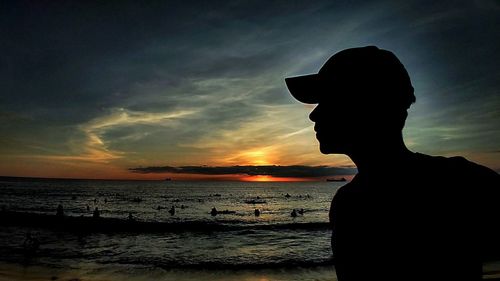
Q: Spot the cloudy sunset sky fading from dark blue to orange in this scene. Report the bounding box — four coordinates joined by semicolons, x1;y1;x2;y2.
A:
0;0;500;180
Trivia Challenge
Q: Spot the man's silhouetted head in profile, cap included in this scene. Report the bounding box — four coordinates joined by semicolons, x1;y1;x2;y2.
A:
285;46;415;154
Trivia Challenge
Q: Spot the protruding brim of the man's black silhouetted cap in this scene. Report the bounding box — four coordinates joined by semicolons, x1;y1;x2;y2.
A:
285;74;321;104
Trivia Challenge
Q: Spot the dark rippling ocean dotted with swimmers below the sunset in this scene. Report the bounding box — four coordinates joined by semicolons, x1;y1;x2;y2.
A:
0;178;345;280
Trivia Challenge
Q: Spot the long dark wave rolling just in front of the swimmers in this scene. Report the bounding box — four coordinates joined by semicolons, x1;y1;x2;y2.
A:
0;211;329;233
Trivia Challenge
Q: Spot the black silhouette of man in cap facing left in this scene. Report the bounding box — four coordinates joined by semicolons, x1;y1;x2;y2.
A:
285;46;500;281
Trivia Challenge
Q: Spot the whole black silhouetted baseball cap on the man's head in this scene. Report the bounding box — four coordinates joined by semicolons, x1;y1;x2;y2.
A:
285;46;415;109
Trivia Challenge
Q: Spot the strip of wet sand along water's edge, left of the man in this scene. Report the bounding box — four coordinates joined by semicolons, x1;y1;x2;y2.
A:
0;263;337;281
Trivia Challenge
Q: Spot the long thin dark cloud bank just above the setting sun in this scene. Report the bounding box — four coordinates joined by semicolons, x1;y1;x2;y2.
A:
129;165;357;178
